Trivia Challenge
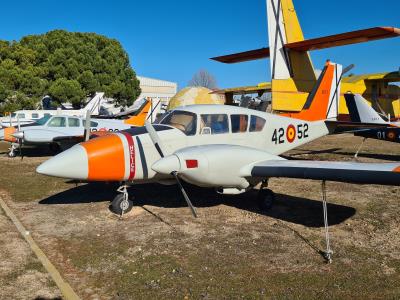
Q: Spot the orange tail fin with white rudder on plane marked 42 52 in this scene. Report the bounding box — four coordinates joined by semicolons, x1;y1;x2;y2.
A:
282;61;342;121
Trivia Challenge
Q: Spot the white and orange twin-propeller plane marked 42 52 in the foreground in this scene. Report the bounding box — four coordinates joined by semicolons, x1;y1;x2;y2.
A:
36;62;400;262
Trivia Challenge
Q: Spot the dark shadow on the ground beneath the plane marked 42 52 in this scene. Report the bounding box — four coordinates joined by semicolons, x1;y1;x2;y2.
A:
39;183;356;227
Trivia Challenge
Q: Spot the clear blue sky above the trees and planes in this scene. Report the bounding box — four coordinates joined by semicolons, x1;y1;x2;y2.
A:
0;0;400;88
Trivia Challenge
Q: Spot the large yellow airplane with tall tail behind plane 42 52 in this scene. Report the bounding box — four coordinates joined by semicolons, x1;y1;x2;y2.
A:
212;0;400;119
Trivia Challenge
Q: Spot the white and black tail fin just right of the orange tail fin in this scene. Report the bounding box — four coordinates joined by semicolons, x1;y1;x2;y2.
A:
344;93;386;124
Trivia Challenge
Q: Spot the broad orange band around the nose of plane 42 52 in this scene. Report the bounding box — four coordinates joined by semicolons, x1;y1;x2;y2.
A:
81;134;125;181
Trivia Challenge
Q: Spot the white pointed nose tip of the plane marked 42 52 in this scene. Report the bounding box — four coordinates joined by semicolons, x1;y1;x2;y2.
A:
36;145;88;180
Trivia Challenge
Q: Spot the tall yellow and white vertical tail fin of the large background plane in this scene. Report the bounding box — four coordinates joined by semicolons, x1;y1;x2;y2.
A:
267;0;317;111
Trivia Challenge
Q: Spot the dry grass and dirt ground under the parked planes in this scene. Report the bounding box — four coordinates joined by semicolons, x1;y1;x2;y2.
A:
0;135;400;299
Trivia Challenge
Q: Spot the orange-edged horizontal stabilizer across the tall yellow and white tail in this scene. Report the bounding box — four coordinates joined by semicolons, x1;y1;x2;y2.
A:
211;27;400;64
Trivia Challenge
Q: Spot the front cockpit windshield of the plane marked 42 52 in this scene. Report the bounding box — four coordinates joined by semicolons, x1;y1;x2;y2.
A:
160;110;197;135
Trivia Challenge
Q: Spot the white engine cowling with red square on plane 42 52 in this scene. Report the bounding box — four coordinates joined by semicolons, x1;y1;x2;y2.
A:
152;145;282;189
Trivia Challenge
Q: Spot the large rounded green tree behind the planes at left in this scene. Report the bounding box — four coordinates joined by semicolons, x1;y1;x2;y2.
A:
0;30;140;111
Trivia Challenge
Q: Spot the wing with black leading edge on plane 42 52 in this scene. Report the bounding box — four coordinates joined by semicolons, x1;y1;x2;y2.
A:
251;160;400;186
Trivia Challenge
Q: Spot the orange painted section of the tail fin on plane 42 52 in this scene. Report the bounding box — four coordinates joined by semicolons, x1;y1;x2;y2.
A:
281;64;335;121
